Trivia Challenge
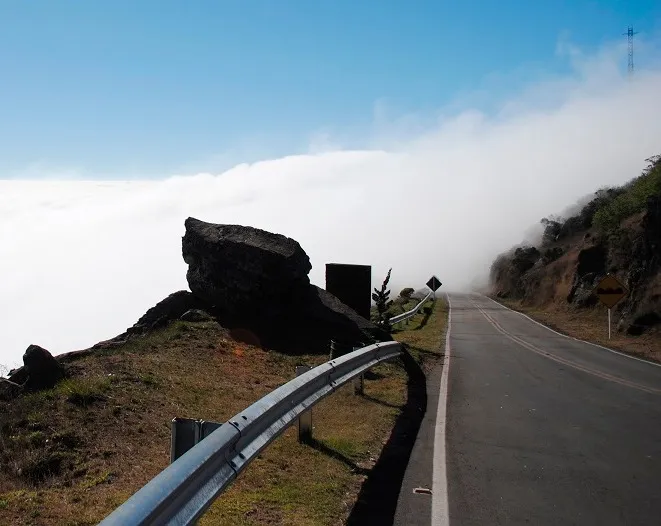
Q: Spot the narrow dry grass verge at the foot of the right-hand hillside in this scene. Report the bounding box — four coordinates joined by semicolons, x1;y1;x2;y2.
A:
495;298;661;362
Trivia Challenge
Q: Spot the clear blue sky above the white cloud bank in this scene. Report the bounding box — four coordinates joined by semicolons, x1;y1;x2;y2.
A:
0;0;661;178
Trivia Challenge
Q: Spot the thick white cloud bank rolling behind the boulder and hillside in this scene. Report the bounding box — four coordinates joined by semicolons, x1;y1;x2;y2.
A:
0;38;661;372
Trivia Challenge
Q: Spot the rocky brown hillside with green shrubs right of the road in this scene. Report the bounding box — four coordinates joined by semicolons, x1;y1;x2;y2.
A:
490;156;661;359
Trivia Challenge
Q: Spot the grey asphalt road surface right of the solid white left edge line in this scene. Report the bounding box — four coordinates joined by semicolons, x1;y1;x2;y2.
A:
440;294;661;526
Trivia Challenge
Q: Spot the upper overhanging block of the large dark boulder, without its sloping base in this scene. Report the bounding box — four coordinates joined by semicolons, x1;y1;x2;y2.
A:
182;217;312;316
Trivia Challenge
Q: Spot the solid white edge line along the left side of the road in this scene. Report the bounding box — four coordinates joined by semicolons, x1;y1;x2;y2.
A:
431;294;452;526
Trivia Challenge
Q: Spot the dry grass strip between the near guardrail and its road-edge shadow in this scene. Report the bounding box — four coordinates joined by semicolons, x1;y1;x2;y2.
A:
200;363;406;525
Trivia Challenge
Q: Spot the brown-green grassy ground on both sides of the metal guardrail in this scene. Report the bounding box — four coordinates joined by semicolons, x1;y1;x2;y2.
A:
0;303;445;526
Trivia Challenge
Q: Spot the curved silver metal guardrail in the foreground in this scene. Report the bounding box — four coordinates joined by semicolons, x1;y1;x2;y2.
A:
100;340;402;526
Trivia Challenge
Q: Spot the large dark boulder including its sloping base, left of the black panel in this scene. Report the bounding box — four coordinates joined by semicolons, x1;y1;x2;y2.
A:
182;218;390;353
